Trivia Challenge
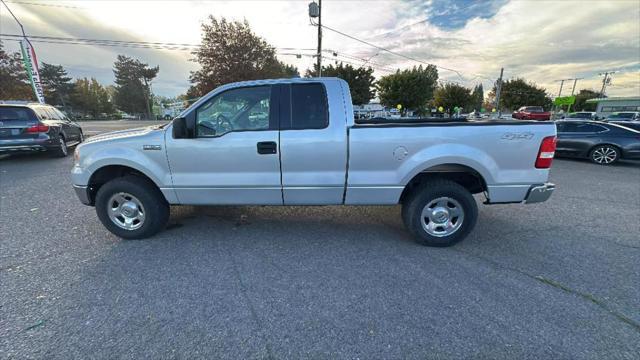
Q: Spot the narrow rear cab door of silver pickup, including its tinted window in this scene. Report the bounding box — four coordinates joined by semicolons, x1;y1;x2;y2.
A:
280;81;348;205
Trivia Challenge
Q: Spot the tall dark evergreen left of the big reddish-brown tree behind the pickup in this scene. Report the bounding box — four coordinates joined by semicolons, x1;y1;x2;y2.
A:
113;55;160;118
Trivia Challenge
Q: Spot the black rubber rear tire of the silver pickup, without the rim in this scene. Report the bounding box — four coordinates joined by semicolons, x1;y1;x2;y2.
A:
402;179;478;247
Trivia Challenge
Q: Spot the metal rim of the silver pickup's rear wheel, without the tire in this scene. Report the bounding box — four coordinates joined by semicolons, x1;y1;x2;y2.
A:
420;197;464;237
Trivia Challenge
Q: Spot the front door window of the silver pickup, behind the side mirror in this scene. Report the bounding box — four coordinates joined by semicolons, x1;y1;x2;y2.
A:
196;86;271;137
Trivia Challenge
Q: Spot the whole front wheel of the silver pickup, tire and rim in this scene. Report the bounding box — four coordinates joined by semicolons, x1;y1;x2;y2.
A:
95;175;169;239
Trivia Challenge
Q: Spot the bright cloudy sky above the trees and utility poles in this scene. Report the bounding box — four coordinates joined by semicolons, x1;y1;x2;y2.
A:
0;0;640;97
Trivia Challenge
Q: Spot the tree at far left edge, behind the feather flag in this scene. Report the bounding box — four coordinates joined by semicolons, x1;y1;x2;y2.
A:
0;41;35;100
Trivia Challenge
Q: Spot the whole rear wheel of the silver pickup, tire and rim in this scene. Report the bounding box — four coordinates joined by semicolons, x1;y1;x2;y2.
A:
403;180;478;247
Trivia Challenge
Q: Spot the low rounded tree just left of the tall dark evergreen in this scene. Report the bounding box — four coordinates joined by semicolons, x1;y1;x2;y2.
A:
70;78;115;117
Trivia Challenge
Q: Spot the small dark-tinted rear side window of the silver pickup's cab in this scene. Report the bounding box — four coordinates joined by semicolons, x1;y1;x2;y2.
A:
290;83;329;129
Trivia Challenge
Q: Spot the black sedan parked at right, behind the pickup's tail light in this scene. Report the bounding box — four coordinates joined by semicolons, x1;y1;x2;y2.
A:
556;120;640;165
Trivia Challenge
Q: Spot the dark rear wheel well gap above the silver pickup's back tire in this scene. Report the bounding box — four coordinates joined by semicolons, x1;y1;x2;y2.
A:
400;164;487;203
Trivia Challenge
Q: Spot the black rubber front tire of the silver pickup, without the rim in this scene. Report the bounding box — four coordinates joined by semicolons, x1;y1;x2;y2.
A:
95;175;169;239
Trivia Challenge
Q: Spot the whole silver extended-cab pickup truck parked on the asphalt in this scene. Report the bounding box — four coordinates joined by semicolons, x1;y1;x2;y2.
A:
72;78;556;246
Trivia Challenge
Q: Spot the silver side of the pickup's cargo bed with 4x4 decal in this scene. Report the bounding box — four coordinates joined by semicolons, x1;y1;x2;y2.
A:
345;119;556;204
